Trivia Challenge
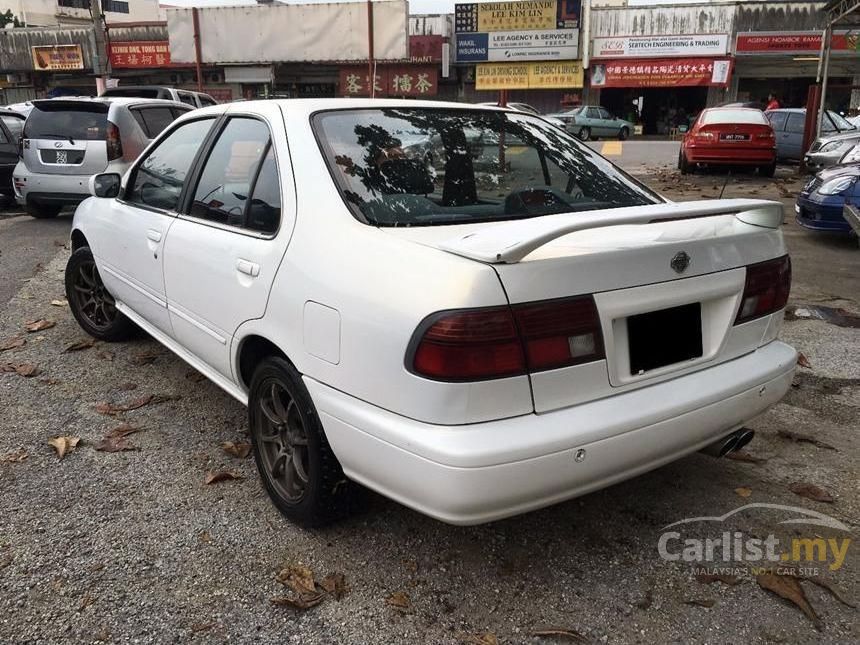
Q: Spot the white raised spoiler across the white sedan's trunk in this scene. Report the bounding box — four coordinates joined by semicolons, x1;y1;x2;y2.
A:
439;199;783;264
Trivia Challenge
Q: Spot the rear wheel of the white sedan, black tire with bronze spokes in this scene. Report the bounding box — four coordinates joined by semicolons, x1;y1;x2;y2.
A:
248;356;359;527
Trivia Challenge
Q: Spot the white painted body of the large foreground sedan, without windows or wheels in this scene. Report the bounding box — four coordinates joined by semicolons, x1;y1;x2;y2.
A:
72;99;796;524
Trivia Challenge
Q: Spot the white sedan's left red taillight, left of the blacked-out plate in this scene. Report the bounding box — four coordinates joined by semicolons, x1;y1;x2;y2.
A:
407;296;604;381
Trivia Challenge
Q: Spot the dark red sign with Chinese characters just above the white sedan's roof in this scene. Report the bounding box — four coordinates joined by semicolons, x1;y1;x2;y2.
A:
340;65;439;97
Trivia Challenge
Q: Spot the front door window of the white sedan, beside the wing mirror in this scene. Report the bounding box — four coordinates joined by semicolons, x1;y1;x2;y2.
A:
125;119;214;210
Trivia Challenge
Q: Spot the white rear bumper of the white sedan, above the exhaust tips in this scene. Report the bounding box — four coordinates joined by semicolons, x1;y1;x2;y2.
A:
305;341;797;525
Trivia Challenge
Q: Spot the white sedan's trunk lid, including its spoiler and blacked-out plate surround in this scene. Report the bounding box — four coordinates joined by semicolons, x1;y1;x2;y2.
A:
381;200;785;412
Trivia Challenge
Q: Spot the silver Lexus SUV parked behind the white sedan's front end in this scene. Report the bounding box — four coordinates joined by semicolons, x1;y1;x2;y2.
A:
13;98;193;218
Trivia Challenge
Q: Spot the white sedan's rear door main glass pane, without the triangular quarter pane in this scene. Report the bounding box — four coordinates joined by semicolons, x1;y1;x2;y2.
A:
191;118;269;226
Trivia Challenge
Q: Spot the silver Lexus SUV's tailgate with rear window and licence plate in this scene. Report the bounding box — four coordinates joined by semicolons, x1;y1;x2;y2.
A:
22;99;109;175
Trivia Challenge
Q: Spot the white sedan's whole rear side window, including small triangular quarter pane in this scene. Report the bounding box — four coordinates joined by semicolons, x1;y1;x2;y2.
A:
191;117;280;232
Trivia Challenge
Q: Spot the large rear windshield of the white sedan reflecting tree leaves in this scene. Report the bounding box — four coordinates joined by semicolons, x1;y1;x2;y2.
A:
313;107;662;226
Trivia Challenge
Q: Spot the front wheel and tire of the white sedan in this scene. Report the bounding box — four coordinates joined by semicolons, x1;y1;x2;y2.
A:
65;246;136;342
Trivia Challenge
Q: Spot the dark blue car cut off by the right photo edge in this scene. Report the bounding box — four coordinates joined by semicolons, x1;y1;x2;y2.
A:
794;163;860;233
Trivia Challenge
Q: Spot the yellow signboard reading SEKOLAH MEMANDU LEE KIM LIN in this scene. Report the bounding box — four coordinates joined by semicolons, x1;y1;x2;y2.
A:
454;0;581;34
